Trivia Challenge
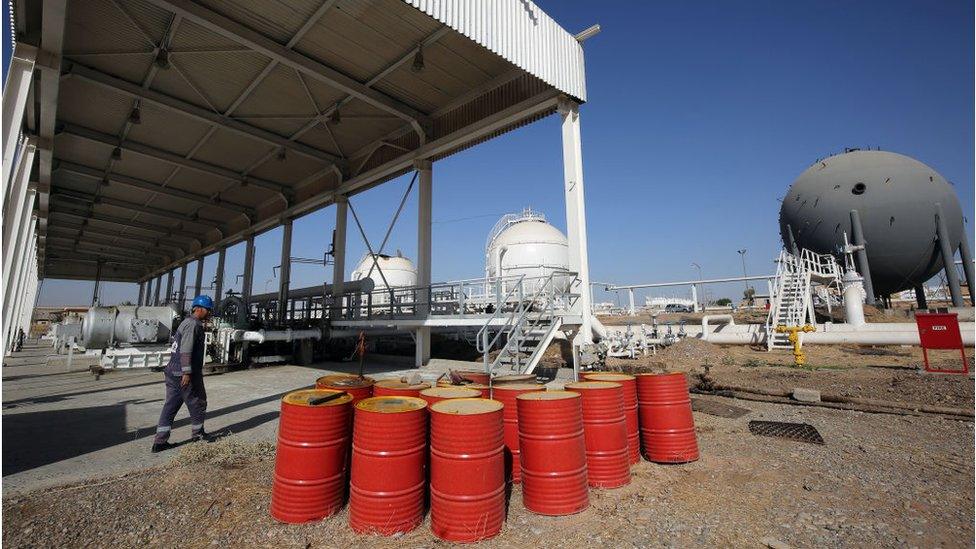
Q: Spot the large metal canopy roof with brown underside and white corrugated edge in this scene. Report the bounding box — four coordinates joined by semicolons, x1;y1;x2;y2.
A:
17;0;585;281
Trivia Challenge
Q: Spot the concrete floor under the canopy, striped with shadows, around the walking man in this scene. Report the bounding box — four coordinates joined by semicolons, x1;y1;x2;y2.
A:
2;341;478;496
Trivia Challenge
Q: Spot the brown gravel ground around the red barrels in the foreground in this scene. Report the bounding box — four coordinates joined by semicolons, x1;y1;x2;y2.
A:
3;397;974;548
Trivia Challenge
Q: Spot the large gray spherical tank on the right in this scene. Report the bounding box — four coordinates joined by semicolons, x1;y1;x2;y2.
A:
779;150;964;295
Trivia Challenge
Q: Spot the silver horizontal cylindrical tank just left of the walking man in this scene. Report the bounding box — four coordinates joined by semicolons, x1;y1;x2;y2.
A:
81;305;177;349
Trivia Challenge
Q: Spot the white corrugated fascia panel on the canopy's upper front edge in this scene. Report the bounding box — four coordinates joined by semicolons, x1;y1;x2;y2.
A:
403;0;586;101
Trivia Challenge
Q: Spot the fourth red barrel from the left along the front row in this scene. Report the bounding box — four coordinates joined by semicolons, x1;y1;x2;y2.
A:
515;391;590;515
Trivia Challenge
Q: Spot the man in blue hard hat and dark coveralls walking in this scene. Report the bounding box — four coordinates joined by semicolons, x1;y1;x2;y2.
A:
152;295;213;453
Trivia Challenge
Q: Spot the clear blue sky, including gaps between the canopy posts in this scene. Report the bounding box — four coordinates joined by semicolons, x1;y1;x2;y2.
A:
3;0;974;305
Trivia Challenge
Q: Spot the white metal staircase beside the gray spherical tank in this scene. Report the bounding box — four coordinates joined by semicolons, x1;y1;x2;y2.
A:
766;249;841;350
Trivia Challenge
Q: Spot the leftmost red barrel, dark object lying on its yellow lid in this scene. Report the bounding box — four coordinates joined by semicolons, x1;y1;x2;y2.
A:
271;389;352;524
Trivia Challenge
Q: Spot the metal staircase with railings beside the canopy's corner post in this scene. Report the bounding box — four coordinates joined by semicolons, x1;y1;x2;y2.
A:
477;272;566;374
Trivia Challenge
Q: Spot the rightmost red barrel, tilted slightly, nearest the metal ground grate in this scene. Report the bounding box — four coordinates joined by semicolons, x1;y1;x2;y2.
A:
637;372;698;463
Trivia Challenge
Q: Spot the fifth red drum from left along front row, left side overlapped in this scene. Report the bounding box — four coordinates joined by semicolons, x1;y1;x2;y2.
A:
566;381;630;488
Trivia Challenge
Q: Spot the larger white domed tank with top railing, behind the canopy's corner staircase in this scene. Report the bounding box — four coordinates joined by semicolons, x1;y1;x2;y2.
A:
485;209;570;292
